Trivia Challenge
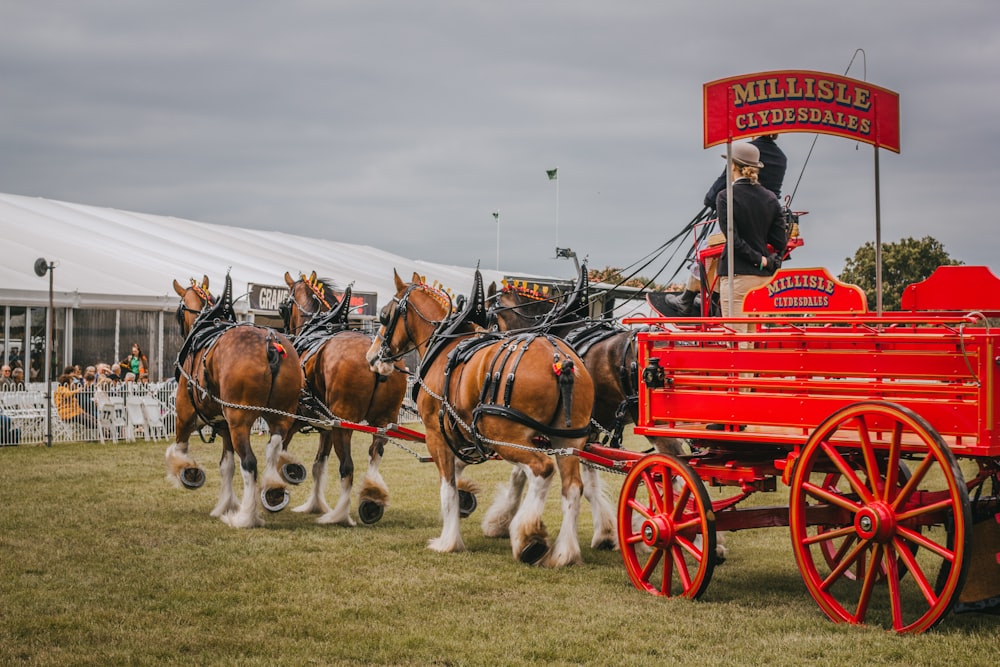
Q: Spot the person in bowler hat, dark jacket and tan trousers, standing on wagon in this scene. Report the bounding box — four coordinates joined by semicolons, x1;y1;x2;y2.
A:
715;143;788;331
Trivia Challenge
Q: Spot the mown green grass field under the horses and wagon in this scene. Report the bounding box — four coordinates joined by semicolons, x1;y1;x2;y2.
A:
0;435;1000;665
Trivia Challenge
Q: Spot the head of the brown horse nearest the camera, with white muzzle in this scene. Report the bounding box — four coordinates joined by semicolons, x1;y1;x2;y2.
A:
365;271;452;375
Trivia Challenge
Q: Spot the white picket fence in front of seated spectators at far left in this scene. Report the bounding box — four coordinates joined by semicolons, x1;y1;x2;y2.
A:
0;381;177;445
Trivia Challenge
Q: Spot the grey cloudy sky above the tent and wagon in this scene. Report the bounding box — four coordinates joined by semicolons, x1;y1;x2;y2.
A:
0;0;1000;281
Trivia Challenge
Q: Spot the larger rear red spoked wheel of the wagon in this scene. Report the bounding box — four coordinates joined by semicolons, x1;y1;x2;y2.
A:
789;401;971;632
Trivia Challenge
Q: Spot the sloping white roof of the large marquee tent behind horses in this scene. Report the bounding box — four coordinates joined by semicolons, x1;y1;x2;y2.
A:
0;193;549;310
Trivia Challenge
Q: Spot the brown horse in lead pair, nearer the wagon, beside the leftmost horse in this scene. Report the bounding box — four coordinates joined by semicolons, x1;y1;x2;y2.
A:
281;271;406;526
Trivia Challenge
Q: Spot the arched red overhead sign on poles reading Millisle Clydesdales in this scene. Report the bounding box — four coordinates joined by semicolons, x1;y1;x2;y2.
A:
704;70;899;153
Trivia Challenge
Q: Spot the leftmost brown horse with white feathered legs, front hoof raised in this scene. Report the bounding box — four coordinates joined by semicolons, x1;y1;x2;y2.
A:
166;275;302;528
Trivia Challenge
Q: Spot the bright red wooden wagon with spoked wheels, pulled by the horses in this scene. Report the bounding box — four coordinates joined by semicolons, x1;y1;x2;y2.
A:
582;267;1000;632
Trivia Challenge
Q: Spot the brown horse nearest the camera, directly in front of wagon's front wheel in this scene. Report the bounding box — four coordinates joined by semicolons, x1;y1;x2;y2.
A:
367;272;613;567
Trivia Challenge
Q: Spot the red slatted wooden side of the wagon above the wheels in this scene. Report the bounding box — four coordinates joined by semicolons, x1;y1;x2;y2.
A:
636;316;1000;456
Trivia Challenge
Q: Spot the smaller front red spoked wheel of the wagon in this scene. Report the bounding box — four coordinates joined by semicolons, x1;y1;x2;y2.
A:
618;454;715;598
